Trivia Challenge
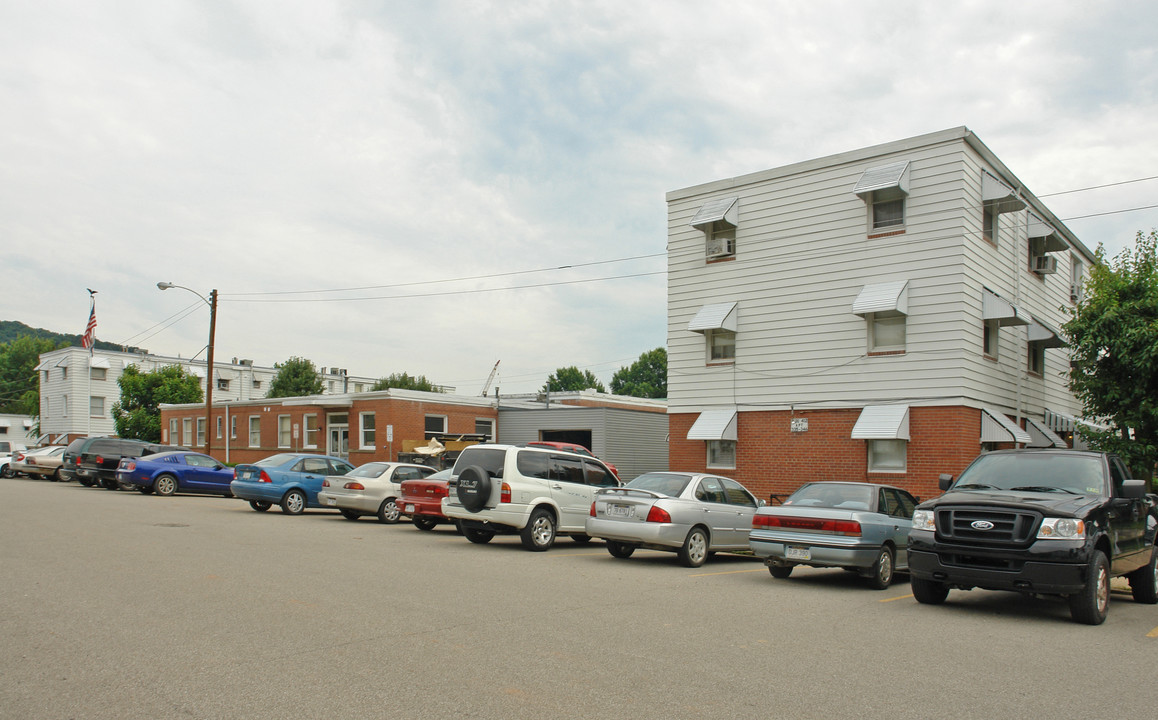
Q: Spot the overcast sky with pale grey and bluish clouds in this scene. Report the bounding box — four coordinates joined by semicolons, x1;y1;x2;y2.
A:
0;0;1158;395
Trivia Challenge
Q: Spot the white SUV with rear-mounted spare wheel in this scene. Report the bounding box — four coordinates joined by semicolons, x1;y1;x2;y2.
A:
442;445;620;551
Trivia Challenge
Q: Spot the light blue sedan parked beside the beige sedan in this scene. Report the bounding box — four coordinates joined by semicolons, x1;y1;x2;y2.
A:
229;453;354;515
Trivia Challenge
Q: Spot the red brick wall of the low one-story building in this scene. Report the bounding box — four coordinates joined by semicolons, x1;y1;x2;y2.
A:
161;398;498;465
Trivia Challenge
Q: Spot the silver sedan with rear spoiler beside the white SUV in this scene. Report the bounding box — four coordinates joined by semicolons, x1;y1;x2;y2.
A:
587;472;762;567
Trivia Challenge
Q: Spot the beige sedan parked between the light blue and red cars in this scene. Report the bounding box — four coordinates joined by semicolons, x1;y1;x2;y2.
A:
317;463;434;524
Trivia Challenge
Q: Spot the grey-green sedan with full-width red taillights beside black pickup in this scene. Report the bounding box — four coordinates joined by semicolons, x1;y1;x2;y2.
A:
749;483;919;590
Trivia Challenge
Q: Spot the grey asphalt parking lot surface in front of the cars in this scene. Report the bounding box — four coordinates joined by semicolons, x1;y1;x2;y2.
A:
0;478;1158;719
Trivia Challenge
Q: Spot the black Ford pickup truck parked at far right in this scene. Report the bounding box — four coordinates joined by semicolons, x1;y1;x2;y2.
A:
909;449;1158;625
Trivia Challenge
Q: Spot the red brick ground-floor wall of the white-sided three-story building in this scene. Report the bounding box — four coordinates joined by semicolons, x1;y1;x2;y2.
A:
668;406;981;499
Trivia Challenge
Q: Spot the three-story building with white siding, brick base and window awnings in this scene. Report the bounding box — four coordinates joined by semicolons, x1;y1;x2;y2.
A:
667;127;1094;495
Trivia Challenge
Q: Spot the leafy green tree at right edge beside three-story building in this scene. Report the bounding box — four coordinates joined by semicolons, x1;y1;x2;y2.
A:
1062;230;1158;479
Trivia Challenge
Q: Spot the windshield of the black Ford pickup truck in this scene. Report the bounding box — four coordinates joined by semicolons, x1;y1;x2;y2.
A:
953;453;1105;493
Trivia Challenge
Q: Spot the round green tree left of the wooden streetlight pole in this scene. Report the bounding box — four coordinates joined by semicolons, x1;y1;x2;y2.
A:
112;365;205;442
